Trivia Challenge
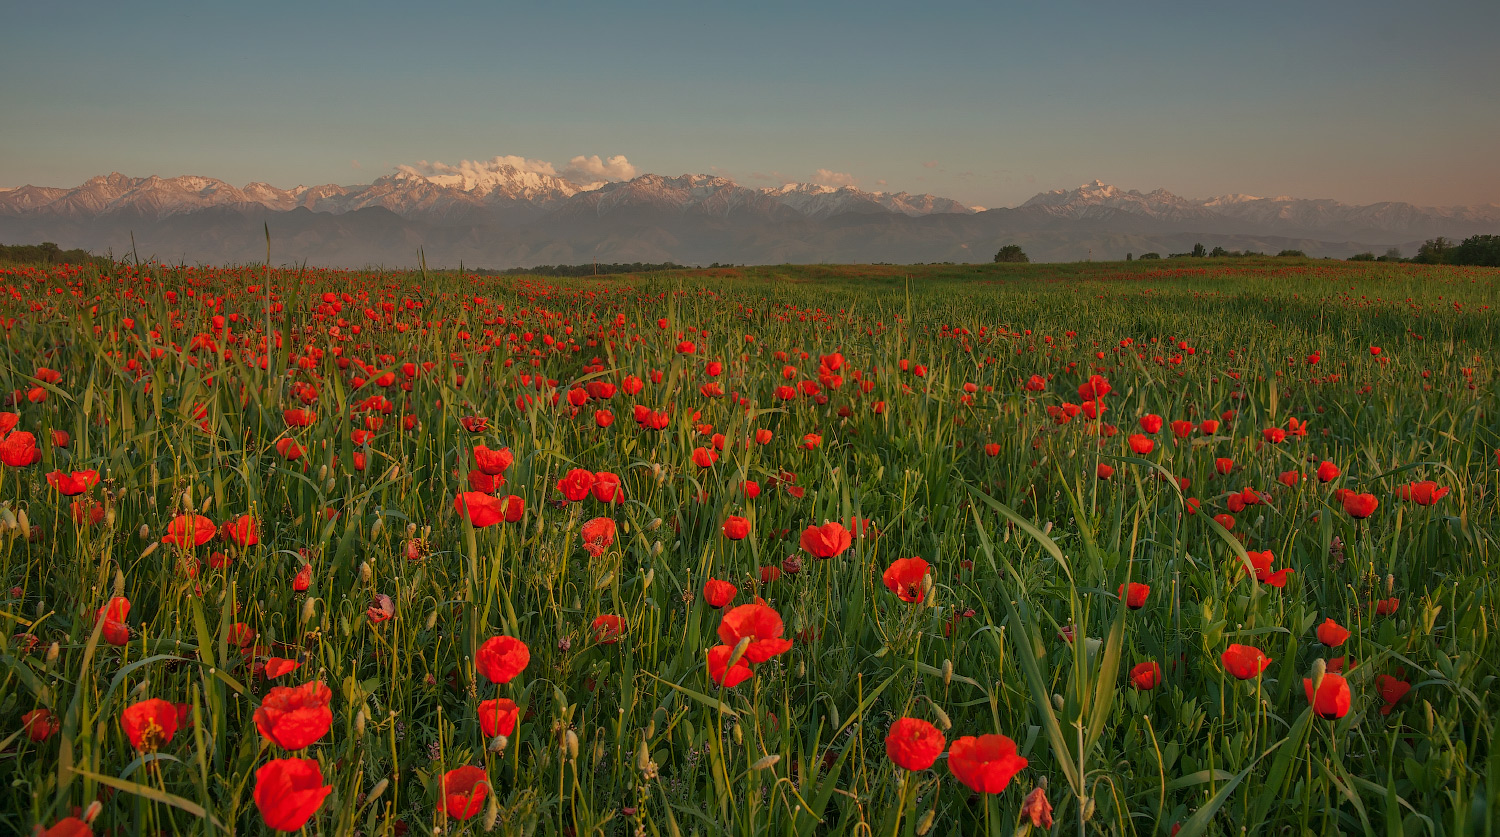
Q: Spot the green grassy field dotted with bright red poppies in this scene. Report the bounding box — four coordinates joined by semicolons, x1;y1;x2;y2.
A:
0;260;1500;837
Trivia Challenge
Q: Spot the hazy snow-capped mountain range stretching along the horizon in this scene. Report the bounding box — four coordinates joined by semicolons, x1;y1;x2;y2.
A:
0;165;1500;269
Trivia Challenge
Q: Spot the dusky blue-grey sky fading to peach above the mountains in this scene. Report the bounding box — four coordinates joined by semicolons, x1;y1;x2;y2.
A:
0;0;1500;207
